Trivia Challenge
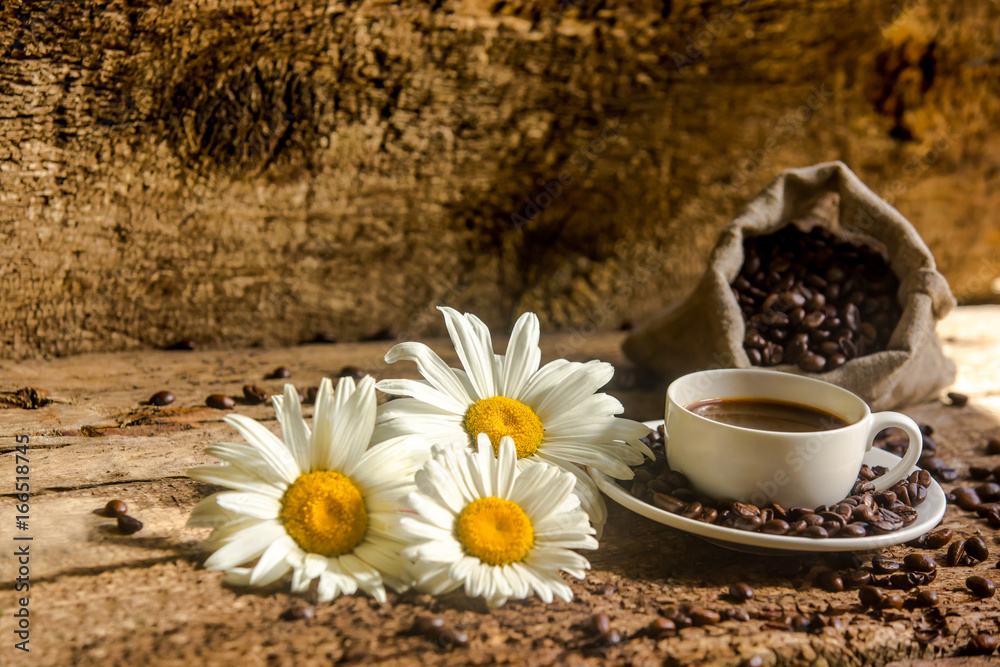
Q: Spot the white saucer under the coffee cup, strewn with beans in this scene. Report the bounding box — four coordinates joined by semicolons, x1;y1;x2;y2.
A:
587;420;946;553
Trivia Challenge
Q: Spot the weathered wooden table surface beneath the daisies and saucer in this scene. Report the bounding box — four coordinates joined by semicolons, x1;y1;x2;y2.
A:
0;306;1000;667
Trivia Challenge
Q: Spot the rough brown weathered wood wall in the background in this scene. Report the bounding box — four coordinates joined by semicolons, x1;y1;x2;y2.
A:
0;0;1000;358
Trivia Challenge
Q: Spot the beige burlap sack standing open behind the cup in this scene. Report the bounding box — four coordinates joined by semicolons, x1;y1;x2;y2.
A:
624;162;955;410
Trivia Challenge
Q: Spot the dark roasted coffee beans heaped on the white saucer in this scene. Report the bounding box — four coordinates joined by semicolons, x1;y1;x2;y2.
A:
631;427;931;539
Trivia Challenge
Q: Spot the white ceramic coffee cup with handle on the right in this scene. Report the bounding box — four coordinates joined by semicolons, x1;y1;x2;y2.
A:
666;369;923;508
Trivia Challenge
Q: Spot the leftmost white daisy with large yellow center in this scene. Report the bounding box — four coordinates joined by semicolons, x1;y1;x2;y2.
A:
188;377;416;602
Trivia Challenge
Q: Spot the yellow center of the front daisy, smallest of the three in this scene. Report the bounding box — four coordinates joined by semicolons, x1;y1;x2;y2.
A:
455;498;535;565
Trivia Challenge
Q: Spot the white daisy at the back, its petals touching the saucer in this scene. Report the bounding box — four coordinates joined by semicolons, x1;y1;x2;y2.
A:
375;308;653;529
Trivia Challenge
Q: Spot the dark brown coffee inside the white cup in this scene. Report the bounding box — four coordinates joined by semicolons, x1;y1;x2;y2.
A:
684;398;847;433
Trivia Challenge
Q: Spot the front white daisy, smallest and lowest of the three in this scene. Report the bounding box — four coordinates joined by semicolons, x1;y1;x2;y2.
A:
401;435;597;607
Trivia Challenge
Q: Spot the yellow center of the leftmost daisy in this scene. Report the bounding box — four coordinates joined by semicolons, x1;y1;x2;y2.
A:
281;470;368;558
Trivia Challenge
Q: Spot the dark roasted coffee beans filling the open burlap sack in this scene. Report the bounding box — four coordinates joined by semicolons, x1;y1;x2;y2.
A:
731;226;902;373
